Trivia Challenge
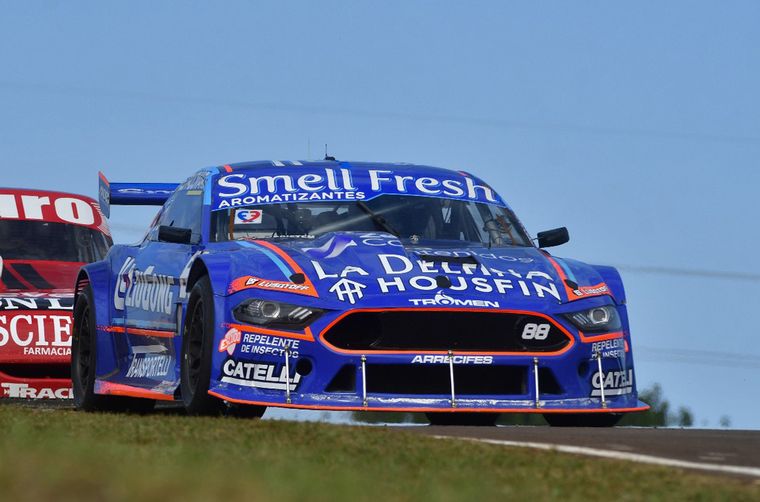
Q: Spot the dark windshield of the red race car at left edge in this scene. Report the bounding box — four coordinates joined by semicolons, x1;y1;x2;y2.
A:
0;220;111;263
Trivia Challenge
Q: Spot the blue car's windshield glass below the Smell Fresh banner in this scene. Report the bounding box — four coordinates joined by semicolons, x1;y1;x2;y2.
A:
213;195;531;246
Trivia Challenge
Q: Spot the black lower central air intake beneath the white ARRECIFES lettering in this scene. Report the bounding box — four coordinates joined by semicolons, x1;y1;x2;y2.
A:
367;364;528;396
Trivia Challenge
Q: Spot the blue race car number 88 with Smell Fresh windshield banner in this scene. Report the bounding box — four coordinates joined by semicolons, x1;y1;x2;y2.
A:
72;158;648;426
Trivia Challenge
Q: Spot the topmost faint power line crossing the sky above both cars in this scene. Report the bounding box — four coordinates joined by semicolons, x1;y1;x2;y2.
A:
0;81;760;144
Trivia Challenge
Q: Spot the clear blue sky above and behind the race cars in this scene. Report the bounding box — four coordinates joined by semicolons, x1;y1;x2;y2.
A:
0;1;760;428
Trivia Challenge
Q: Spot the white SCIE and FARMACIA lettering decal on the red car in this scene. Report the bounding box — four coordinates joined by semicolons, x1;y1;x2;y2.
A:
0;311;71;359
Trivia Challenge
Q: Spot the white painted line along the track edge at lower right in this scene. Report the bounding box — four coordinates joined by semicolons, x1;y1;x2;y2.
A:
434;436;760;478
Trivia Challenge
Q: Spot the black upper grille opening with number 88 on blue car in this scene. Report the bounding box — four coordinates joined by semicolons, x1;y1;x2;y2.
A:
323;310;571;353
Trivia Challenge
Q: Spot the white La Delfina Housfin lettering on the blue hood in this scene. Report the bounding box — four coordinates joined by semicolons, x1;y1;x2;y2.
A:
311;254;561;306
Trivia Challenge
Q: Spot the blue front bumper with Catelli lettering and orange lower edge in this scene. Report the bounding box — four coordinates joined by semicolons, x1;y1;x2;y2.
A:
209;304;648;413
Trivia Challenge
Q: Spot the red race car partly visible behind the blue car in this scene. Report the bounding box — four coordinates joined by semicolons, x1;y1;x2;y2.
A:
0;188;113;399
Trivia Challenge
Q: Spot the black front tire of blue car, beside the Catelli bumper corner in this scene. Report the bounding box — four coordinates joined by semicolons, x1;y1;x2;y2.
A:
180;276;223;415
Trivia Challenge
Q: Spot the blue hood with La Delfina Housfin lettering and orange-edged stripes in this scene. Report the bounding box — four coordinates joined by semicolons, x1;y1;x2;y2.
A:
218;232;609;309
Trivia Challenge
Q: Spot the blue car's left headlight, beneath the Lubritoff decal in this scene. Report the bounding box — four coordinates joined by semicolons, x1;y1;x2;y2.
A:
232;300;323;330
